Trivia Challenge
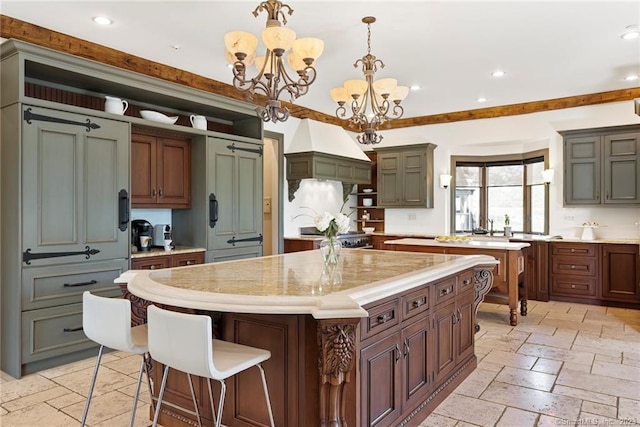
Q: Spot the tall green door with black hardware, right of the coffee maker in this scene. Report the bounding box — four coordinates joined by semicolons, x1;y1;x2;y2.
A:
207;137;263;253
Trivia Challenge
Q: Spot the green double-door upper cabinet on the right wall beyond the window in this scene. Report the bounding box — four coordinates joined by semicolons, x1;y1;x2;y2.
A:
560;126;640;205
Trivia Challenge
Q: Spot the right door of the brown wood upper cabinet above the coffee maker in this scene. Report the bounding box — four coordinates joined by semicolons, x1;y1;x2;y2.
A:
157;137;191;207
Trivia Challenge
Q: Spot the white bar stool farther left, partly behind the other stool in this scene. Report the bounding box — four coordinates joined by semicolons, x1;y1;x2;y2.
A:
81;291;153;426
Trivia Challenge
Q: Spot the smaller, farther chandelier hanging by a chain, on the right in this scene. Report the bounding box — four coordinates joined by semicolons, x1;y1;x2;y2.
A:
331;16;409;145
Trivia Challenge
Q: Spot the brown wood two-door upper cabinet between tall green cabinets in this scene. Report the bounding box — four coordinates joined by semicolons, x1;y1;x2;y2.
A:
131;132;191;209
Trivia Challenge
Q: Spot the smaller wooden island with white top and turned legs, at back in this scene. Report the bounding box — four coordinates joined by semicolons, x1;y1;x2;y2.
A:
384;238;529;326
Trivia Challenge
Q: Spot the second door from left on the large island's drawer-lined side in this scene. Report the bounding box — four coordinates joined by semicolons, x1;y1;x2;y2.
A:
402;315;433;408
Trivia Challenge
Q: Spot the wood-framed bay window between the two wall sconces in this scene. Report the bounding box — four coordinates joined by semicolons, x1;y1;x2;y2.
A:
452;150;548;234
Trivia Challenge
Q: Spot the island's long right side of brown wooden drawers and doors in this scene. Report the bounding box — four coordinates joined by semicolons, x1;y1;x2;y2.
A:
360;271;475;426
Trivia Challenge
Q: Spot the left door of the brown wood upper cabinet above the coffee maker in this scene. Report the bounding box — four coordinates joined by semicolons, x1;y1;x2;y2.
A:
131;133;158;207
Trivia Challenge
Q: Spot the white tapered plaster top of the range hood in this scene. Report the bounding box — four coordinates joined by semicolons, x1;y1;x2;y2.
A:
286;119;370;162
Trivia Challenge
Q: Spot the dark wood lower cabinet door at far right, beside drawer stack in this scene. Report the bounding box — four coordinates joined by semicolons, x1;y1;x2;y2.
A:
602;244;640;302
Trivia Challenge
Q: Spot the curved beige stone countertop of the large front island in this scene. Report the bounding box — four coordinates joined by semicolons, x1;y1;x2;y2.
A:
121;249;497;319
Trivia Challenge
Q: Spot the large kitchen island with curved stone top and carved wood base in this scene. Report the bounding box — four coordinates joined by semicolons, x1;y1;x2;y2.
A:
118;249;496;427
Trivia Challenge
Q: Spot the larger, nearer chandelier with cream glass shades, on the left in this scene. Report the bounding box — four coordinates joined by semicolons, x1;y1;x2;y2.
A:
224;0;324;123
